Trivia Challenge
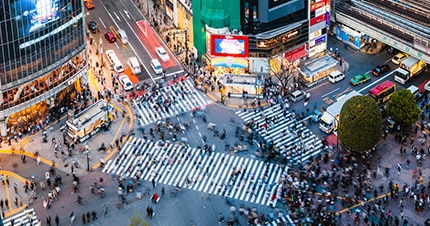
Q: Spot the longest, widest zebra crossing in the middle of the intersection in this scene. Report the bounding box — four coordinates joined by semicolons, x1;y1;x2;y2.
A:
103;137;284;205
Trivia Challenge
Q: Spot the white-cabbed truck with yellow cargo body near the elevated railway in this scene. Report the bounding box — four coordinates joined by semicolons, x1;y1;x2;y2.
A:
394;57;427;85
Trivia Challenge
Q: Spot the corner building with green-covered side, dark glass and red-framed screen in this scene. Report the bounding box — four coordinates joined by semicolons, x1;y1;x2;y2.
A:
192;0;330;74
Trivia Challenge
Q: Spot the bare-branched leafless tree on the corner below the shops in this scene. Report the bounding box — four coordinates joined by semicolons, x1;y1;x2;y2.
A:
269;57;296;95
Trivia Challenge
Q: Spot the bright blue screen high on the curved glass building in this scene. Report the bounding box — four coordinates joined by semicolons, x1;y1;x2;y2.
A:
10;0;73;37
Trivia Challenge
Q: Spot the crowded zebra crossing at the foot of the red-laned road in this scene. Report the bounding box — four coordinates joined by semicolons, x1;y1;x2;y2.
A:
133;79;212;126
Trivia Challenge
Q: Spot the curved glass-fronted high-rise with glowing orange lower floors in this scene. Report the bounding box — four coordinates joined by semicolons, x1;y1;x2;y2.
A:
0;0;87;136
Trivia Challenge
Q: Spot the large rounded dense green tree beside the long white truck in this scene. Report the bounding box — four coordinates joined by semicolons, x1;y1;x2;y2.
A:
338;96;382;153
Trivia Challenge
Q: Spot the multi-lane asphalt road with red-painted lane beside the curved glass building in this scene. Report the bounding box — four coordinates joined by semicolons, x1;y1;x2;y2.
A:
85;0;183;82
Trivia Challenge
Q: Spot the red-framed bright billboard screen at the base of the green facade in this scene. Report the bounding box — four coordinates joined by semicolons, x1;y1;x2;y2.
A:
210;35;248;57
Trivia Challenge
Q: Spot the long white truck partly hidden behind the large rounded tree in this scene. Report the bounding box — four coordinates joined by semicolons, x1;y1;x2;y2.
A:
319;90;361;134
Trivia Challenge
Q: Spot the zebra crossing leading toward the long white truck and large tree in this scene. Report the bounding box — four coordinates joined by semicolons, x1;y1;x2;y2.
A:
236;105;324;163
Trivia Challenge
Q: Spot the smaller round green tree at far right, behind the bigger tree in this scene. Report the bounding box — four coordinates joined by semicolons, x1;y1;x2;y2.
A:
386;89;421;127
